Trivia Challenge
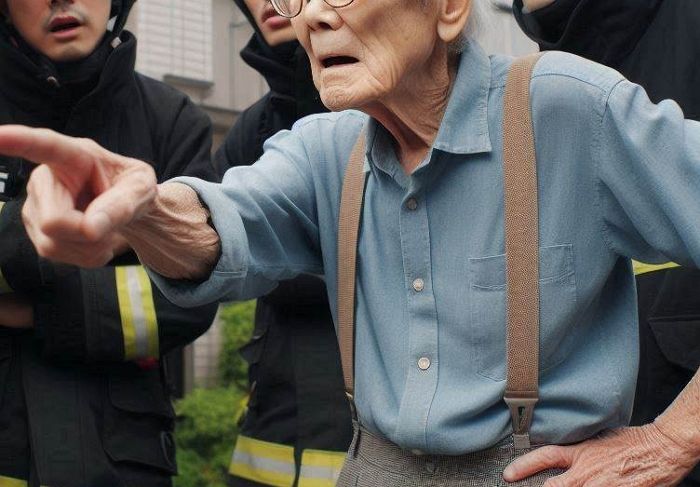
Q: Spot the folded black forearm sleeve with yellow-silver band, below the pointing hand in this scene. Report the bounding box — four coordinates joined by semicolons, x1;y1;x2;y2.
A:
34;265;217;362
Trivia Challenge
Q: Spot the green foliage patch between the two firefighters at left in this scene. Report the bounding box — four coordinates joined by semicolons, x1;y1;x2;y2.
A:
174;301;255;487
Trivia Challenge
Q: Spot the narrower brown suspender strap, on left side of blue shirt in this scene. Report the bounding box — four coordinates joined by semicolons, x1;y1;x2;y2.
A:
338;130;366;400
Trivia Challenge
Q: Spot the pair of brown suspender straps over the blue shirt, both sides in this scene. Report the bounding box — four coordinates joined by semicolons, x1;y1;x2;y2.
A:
338;54;540;449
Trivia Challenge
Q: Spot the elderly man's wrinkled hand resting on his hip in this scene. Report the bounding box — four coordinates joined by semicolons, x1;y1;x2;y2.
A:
504;423;697;487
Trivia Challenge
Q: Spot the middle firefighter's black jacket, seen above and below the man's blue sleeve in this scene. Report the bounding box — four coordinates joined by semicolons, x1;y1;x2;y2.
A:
215;24;352;487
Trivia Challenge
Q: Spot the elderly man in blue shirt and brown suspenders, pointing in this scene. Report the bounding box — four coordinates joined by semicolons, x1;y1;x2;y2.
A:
0;0;700;487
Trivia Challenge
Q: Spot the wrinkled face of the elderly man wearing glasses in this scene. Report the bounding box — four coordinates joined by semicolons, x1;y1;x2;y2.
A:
292;0;439;111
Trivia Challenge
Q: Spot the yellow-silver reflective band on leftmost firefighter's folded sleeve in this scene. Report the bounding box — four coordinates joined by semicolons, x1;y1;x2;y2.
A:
115;266;159;360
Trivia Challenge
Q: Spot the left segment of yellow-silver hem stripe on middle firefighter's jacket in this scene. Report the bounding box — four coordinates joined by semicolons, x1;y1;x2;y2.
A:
229;435;296;487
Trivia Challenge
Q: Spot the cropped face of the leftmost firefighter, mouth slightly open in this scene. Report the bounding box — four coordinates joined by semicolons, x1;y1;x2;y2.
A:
0;0;111;62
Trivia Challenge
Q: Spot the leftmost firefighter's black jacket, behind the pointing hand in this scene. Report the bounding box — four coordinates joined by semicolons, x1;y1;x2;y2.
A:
0;32;216;487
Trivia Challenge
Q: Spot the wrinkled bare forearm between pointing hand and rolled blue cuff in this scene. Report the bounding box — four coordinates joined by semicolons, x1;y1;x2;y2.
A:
122;183;221;280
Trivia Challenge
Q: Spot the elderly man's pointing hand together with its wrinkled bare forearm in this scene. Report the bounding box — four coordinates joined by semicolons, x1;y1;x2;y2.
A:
0;125;220;279
